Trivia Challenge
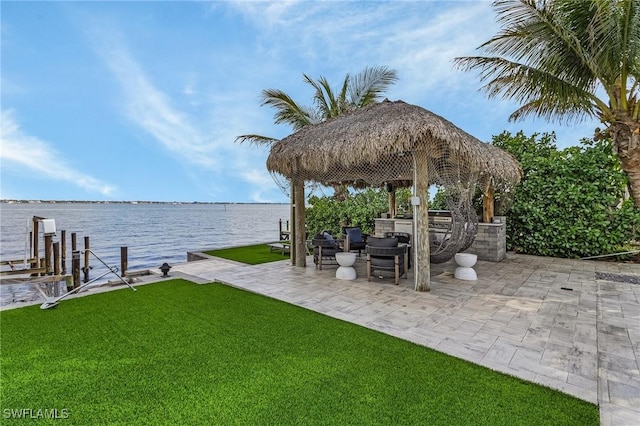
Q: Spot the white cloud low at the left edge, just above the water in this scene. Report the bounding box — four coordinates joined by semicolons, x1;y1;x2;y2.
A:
0;110;116;196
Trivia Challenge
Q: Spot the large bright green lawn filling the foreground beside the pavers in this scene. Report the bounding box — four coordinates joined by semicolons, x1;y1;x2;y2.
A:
0;280;599;426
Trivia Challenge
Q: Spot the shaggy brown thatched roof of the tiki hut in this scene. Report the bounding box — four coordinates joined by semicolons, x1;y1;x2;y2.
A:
267;100;522;186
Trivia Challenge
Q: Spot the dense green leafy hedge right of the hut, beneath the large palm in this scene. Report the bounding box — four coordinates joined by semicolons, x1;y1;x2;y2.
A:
493;132;640;257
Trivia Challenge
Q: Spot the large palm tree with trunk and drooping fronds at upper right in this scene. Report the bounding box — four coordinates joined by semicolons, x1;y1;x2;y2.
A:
455;0;640;208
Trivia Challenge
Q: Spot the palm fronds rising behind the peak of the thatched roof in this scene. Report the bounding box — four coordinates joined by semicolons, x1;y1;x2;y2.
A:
236;67;398;144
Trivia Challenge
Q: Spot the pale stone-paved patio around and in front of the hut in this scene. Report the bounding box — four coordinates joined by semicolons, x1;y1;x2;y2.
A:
171;253;640;425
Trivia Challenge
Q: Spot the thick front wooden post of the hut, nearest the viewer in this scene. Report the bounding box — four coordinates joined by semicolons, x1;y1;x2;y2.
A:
412;151;431;291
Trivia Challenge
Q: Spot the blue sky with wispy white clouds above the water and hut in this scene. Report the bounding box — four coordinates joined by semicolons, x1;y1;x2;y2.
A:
0;0;598;203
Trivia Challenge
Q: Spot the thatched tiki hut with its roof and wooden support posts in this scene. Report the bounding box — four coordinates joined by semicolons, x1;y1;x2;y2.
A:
267;100;522;291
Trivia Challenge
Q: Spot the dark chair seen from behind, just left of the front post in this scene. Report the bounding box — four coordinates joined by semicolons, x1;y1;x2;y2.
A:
366;237;409;285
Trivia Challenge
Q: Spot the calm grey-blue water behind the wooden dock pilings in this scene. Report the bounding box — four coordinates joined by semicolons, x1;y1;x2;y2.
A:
0;203;289;279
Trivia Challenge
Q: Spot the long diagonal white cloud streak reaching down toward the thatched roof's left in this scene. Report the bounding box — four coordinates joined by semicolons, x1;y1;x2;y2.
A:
83;20;290;202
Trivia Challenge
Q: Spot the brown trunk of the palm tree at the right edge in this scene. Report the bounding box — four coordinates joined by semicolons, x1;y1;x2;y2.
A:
610;120;640;208
